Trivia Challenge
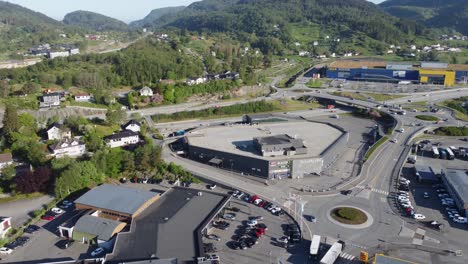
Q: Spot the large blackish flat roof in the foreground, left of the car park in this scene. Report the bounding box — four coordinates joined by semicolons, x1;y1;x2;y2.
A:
107;187;230;263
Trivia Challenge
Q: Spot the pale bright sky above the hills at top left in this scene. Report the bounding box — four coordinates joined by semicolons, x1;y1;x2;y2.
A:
3;0;383;23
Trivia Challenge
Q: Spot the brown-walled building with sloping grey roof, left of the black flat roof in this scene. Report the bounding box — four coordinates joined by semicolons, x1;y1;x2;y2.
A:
75;184;160;221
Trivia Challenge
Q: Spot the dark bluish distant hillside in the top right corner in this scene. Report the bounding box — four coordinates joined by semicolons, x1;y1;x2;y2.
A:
380;0;468;34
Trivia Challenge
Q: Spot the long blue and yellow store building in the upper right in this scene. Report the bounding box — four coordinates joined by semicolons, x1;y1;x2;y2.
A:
326;60;468;86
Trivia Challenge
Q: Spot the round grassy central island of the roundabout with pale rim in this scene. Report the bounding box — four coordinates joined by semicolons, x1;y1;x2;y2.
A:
327;206;374;229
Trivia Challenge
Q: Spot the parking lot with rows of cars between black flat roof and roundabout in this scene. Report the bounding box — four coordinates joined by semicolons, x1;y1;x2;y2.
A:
204;192;305;263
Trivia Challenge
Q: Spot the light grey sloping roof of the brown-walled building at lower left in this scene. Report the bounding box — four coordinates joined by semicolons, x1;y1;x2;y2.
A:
75;184;159;214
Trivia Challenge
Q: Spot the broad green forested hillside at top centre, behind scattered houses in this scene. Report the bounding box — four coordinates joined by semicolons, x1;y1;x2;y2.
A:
149;0;425;51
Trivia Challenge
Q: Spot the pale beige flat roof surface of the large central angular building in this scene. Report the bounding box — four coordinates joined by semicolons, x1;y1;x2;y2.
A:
187;120;343;160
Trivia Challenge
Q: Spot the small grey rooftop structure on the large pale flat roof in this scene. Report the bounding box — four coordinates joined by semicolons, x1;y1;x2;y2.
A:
253;134;307;157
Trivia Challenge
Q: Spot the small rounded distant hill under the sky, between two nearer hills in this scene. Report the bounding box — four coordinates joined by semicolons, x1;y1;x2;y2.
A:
63;10;128;31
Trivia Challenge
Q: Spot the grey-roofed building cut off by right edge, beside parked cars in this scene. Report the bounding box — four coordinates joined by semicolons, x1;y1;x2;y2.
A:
442;169;468;216
